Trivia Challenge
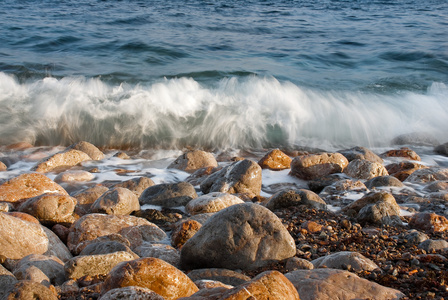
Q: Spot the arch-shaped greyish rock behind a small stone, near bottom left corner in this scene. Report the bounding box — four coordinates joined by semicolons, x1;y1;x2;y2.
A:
14;254;65;285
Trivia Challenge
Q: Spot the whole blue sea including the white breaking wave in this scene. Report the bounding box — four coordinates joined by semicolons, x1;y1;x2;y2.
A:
0;0;448;148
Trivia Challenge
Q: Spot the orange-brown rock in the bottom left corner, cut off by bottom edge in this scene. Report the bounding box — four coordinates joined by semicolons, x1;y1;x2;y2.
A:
2;280;58;300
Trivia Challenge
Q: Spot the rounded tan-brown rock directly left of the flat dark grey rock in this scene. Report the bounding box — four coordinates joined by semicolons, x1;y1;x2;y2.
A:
90;187;140;215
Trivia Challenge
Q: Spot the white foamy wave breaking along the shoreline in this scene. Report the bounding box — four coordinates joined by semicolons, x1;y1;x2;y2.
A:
0;72;448;149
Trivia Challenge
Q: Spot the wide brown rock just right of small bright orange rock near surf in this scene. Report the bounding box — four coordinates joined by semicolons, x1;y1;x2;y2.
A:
289;153;348;180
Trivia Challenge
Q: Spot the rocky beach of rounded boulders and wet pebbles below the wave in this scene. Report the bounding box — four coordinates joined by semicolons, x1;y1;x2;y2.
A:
0;133;448;300
